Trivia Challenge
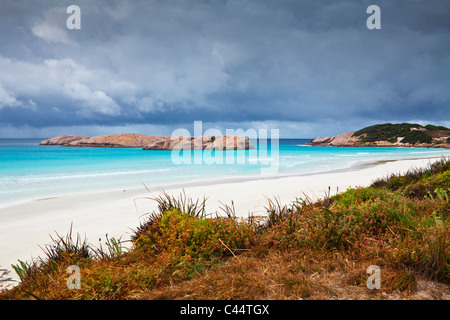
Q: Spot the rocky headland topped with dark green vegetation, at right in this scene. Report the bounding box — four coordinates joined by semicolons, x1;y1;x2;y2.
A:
306;123;450;148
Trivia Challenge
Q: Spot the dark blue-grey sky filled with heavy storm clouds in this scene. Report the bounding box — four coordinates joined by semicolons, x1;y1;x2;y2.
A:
0;0;450;138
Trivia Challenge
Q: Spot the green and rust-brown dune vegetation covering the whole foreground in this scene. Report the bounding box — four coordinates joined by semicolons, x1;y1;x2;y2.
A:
0;159;450;299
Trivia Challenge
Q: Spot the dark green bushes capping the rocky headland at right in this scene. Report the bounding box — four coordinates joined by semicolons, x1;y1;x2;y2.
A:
353;123;450;144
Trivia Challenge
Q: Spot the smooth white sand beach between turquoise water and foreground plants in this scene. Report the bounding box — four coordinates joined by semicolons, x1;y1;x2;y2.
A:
0;158;444;286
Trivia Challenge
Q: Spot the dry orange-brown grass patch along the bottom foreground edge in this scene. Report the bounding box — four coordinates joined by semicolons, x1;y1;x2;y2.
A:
127;248;450;300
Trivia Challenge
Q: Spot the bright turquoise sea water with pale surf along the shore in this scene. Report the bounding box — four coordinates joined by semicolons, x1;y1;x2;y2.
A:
0;139;450;207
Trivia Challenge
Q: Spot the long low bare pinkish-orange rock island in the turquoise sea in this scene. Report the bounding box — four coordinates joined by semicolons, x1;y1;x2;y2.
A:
40;133;255;150
